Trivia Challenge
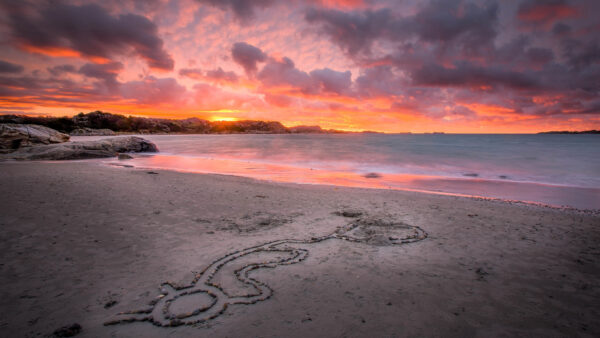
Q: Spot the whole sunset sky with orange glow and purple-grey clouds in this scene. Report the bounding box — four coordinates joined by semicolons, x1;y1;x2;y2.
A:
0;0;600;133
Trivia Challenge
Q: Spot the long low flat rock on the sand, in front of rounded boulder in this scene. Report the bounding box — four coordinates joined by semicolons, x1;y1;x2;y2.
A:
0;136;158;160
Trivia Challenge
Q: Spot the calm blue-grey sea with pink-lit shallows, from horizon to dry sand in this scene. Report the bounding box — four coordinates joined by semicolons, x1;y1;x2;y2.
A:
77;134;600;209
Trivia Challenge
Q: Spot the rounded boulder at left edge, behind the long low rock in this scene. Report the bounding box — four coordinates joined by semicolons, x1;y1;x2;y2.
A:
0;123;69;153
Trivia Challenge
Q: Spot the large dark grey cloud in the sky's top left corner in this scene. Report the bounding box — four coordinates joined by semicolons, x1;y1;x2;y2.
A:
5;3;174;70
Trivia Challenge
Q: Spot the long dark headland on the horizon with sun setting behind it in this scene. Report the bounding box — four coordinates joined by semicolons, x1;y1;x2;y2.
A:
0;111;345;134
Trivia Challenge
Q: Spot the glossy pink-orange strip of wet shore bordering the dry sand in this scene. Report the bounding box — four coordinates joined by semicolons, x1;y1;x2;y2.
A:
117;155;600;209
